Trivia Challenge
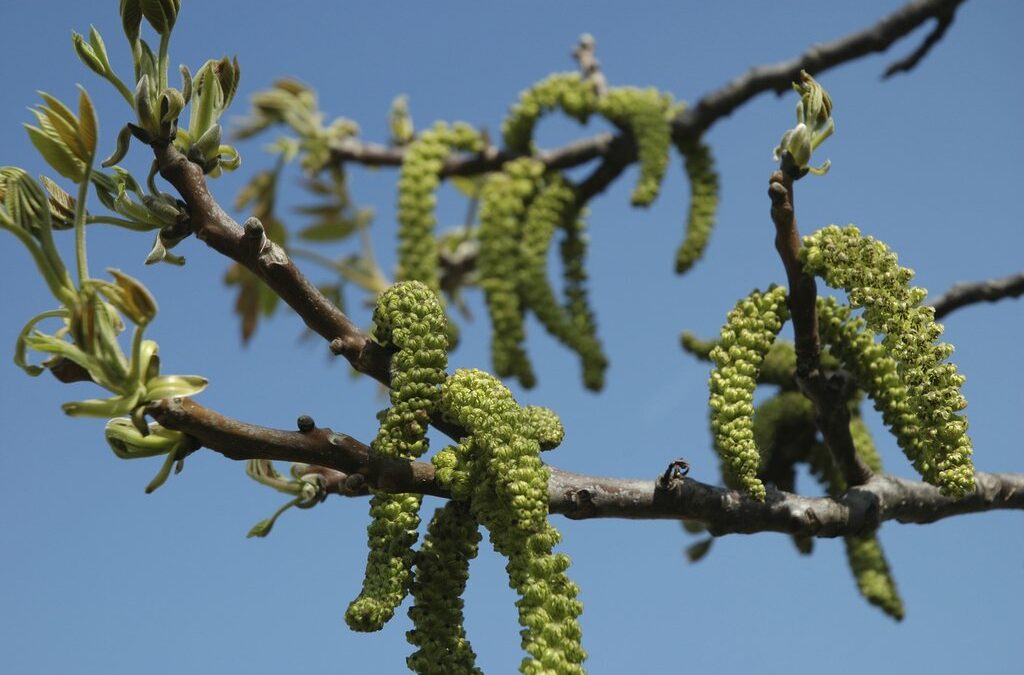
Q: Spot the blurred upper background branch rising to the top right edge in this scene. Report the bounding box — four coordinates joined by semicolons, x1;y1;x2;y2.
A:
331;0;964;177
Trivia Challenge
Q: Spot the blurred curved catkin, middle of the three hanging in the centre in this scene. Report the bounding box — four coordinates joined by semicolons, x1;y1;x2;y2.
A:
518;173;607;390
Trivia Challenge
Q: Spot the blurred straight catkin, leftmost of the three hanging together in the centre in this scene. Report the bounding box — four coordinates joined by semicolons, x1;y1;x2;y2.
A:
477;158;544;388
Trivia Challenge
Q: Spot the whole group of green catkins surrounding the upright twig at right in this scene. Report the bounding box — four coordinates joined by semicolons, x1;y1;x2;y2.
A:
682;225;975;620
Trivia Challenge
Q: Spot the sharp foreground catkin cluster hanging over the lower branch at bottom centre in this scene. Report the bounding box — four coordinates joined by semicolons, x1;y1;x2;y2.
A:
345;282;586;675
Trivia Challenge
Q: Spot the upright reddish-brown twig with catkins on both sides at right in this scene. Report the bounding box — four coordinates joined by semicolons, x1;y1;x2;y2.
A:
768;167;871;486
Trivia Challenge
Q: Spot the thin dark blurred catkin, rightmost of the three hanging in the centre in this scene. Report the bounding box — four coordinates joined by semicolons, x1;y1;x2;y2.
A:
558;212;608;391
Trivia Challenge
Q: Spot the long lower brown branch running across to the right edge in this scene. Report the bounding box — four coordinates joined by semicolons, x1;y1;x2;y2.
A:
146;398;1024;537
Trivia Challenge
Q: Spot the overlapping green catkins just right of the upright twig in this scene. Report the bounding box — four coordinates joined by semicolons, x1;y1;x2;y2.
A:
800;225;975;499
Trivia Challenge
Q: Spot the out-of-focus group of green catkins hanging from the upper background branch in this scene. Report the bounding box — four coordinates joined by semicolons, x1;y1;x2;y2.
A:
397;73;718;390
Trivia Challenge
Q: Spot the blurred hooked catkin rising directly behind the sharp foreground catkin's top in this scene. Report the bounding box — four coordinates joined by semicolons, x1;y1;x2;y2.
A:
396;122;483;294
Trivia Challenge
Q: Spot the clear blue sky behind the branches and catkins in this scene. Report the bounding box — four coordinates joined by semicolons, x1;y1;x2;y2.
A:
0;0;1024;675
